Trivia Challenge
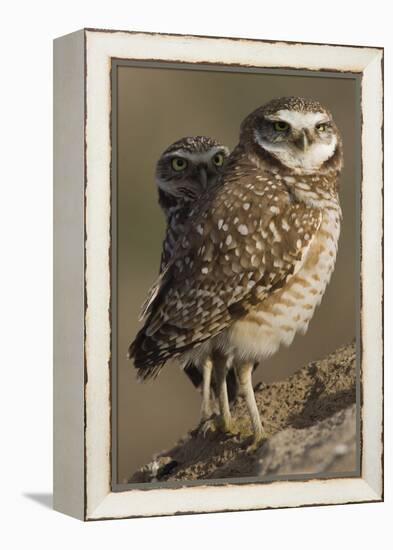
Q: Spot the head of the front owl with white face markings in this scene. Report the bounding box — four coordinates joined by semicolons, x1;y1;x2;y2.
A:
240;97;342;173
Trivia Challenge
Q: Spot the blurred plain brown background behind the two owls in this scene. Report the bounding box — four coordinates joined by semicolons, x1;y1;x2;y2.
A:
114;66;360;483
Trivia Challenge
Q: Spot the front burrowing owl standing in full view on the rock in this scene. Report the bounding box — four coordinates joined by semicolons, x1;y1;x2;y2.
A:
130;97;342;445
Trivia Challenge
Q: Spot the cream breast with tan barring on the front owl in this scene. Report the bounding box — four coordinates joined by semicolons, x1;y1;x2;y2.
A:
226;205;341;361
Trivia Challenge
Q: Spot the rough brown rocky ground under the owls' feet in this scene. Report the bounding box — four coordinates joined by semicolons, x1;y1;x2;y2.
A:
129;343;356;483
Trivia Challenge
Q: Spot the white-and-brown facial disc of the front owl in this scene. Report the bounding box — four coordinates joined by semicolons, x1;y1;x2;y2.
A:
254;109;337;172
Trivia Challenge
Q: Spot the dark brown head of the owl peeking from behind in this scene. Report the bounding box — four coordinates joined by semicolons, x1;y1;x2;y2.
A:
156;136;229;216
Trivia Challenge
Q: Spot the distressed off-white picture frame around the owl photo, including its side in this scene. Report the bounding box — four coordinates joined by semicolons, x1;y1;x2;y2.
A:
54;29;383;520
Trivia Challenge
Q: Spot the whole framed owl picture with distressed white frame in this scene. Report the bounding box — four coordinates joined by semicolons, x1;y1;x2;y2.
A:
54;29;383;520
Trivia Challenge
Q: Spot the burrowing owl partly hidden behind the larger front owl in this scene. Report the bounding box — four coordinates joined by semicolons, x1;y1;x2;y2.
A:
151;136;230;422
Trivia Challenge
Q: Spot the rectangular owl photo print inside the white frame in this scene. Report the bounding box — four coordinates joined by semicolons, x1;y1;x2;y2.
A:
111;61;361;490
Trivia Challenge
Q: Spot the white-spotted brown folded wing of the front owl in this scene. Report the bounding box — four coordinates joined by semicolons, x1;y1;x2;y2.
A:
129;174;321;378
